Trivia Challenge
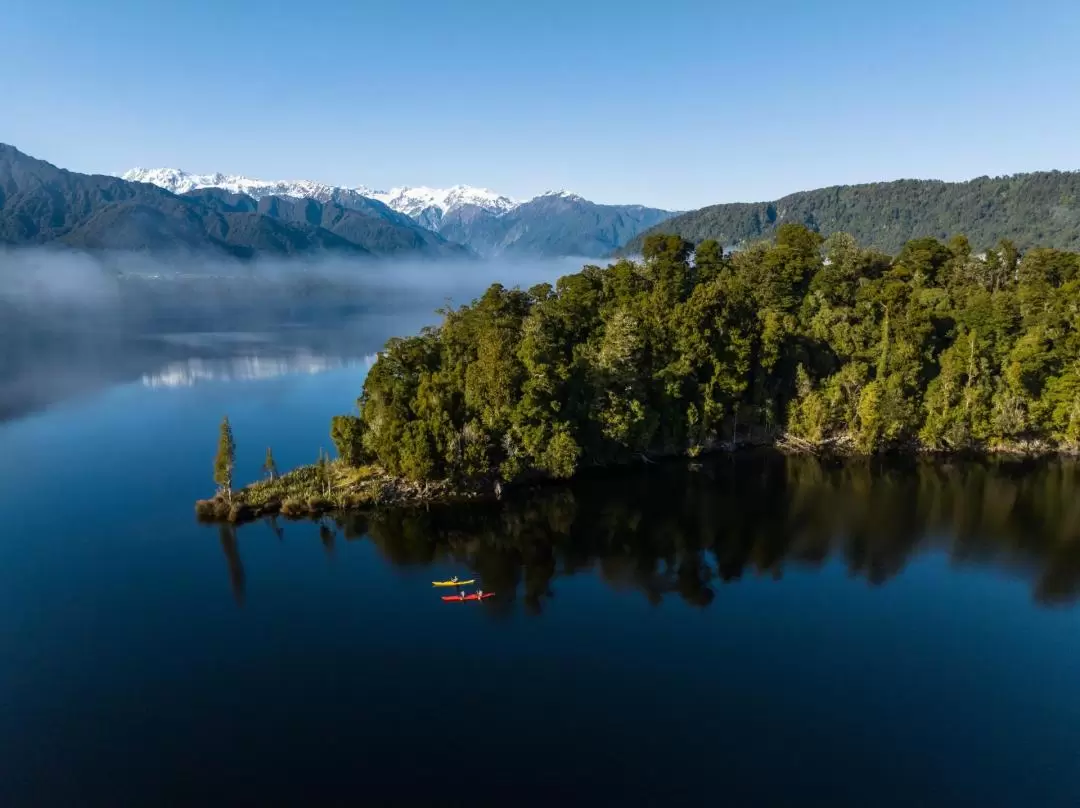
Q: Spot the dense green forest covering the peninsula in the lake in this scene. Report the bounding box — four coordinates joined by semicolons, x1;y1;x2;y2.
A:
333;224;1080;481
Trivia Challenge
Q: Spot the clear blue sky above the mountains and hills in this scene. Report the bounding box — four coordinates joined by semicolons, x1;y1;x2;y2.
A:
0;0;1080;208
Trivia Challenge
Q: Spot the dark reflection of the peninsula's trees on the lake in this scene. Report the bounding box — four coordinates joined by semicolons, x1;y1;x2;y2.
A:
214;453;1080;614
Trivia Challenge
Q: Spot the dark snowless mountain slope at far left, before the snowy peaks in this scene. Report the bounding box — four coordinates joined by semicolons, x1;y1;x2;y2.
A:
0;144;467;258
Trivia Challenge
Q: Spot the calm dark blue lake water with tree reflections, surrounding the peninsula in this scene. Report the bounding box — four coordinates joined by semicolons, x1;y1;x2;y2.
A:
0;283;1080;807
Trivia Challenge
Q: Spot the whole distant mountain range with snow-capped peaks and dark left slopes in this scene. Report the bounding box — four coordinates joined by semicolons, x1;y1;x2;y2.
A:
0;144;671;259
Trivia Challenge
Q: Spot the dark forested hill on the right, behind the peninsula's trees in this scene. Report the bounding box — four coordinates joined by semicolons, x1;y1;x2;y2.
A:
620;171;1080;255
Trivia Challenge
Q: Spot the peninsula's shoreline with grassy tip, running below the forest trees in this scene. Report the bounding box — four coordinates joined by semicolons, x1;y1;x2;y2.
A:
194;435;1080;525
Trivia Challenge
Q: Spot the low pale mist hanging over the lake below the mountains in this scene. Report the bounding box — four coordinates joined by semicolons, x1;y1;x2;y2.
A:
0;248;585;418
